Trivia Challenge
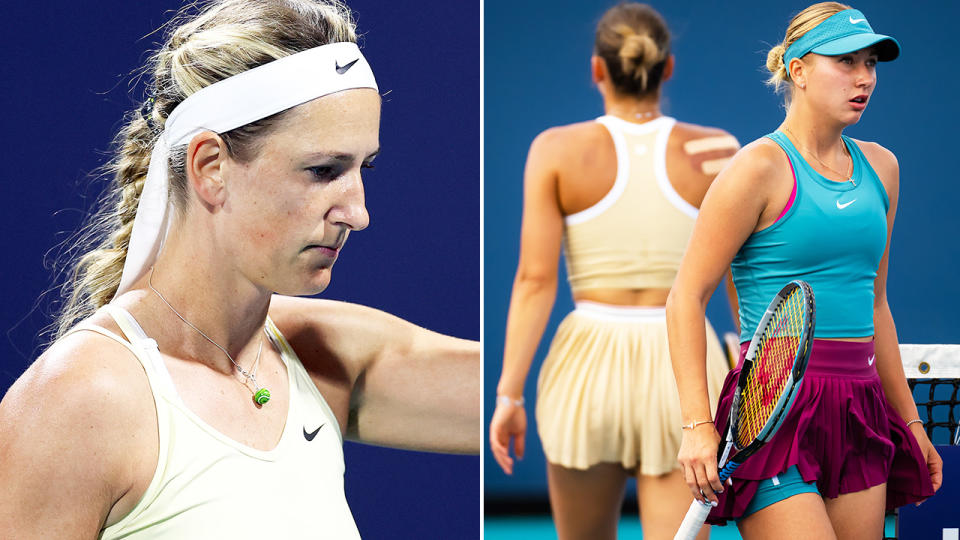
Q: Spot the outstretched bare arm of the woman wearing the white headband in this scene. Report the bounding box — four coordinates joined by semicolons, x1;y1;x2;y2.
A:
270;296;482;453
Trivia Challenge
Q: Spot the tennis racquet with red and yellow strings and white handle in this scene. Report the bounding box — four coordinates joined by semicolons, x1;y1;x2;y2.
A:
673;280;816;540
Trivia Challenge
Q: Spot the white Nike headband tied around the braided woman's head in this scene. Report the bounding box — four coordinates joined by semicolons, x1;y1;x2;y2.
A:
115;42;377;296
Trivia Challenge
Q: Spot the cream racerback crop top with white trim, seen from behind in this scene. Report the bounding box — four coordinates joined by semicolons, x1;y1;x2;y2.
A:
564;115;697;292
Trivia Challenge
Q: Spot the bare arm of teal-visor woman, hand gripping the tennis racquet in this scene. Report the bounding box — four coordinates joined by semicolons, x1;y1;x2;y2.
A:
667;141;792;501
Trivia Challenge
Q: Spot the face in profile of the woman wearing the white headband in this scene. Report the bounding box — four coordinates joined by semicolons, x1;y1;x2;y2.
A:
223;89;380;295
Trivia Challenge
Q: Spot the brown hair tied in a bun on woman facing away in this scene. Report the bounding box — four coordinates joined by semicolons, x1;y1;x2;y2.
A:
594;2;670;97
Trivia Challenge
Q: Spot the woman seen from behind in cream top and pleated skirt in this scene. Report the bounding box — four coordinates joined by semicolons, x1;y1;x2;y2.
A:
490;3;738;539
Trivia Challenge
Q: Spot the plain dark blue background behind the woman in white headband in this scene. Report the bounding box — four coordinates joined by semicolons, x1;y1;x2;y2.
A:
0;0;481;538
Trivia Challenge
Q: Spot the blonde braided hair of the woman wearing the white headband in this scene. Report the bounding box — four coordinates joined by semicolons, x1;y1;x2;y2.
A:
52;0;357;338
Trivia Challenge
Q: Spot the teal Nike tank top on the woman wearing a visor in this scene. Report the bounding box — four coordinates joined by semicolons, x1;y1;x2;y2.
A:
731;131;890;342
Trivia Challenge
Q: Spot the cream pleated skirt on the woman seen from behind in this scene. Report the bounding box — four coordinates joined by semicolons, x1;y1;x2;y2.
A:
536;302;729;475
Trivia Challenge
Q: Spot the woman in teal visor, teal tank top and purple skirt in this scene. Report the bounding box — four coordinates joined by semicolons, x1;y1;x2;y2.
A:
667;2;941;539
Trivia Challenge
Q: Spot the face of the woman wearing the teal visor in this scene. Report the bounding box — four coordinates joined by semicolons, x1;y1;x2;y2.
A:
805;48;877;125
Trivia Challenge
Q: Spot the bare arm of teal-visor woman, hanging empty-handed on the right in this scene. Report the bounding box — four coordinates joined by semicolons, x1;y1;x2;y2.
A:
861;143;943;490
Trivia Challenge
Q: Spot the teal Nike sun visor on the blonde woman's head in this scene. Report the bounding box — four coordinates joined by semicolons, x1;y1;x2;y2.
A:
783;9;900;76
